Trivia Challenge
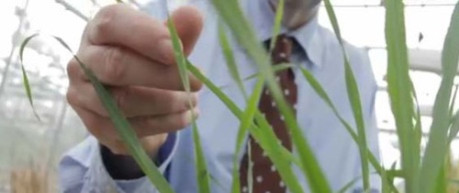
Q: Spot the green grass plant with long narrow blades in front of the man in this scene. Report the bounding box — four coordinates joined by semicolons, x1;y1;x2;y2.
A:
20;0;459;193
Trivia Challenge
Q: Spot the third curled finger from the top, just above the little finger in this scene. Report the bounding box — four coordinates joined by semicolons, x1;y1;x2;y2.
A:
67;79;197;117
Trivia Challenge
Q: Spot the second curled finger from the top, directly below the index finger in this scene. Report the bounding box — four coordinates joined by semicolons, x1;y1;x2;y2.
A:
75;45;202;91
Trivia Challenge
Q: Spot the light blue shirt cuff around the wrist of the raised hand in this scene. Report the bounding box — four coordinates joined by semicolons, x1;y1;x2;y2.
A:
83;133;178;193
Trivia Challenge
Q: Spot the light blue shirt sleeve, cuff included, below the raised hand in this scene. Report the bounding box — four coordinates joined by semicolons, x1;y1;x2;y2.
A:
59;133;178;193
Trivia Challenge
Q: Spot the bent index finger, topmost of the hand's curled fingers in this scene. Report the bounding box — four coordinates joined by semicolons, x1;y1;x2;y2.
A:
85;5;173;64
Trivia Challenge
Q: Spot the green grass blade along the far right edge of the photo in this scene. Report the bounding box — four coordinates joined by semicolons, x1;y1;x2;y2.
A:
420;2;459;192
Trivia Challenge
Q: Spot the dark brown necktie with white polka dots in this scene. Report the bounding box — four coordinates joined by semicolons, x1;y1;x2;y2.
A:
239;35;297;193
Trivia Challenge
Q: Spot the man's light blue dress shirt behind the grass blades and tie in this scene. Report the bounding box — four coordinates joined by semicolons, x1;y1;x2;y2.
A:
60;0;380;193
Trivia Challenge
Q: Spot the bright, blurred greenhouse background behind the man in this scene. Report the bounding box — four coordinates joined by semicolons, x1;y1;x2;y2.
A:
0;0;459;193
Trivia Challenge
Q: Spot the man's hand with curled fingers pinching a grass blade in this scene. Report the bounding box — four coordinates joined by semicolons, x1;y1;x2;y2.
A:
67;4;202;156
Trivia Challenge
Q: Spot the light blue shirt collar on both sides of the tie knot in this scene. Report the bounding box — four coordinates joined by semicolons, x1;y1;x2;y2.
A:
241;0;324;67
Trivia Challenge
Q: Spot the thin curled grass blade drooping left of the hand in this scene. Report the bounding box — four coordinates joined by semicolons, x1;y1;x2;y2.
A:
19;34;41;121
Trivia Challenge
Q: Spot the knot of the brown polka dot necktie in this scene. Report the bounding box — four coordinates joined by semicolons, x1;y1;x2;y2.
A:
271;35;293;64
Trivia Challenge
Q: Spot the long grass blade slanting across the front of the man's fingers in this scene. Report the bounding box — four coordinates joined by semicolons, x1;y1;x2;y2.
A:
21;34;174;193
